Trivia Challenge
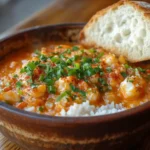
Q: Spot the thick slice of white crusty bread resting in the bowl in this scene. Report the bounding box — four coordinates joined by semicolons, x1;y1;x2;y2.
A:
80;0;150;62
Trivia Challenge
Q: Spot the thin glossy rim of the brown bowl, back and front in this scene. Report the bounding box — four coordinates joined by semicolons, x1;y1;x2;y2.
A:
0;23;150;124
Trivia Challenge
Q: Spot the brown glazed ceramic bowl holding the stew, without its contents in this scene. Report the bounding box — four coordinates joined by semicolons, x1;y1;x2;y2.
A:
0;24;150;150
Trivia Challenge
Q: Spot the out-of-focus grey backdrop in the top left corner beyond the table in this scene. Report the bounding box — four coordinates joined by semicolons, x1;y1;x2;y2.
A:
0;0;51;33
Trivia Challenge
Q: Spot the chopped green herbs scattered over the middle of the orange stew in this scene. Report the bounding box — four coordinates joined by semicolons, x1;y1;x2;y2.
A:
20;46;112;99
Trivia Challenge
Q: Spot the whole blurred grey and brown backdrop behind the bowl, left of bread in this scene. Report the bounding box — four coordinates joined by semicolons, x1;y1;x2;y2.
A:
0;0;120;37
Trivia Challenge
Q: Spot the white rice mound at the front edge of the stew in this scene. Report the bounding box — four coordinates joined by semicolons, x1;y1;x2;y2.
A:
60;101;126;117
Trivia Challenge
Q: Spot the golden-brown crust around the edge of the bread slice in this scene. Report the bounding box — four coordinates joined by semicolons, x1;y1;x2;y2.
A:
79;0;150;62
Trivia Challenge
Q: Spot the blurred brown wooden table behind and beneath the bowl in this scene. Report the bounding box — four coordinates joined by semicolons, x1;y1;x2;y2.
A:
0;0;150;150
